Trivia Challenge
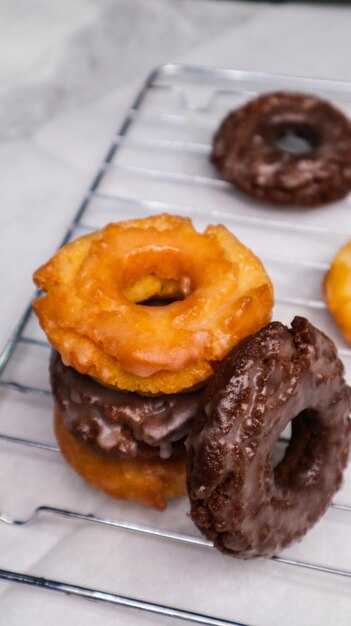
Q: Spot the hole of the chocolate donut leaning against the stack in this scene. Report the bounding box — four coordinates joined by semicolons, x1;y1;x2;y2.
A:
272;408;328;489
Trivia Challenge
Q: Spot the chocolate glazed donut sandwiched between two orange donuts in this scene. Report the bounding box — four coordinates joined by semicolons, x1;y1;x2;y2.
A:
50;352;202;459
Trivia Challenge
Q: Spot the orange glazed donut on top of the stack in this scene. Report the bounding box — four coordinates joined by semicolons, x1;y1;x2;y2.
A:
33;215;273;394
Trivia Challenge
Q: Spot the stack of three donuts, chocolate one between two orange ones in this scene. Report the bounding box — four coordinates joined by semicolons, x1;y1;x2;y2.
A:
33;215;273;509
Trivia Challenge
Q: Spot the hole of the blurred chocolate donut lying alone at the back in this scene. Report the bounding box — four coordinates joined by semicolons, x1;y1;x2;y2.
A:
273;124;319;156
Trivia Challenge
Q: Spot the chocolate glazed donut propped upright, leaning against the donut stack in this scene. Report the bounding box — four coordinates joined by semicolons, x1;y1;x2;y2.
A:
187;317;351;559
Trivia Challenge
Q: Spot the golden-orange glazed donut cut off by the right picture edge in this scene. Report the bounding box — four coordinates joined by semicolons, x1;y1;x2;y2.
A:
324;241;351;342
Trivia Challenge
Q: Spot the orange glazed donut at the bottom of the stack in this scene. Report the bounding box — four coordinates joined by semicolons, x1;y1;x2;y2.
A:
54;408;186;511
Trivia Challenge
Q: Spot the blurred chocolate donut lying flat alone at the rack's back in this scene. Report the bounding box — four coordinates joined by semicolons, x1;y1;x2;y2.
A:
210;92;351;207
